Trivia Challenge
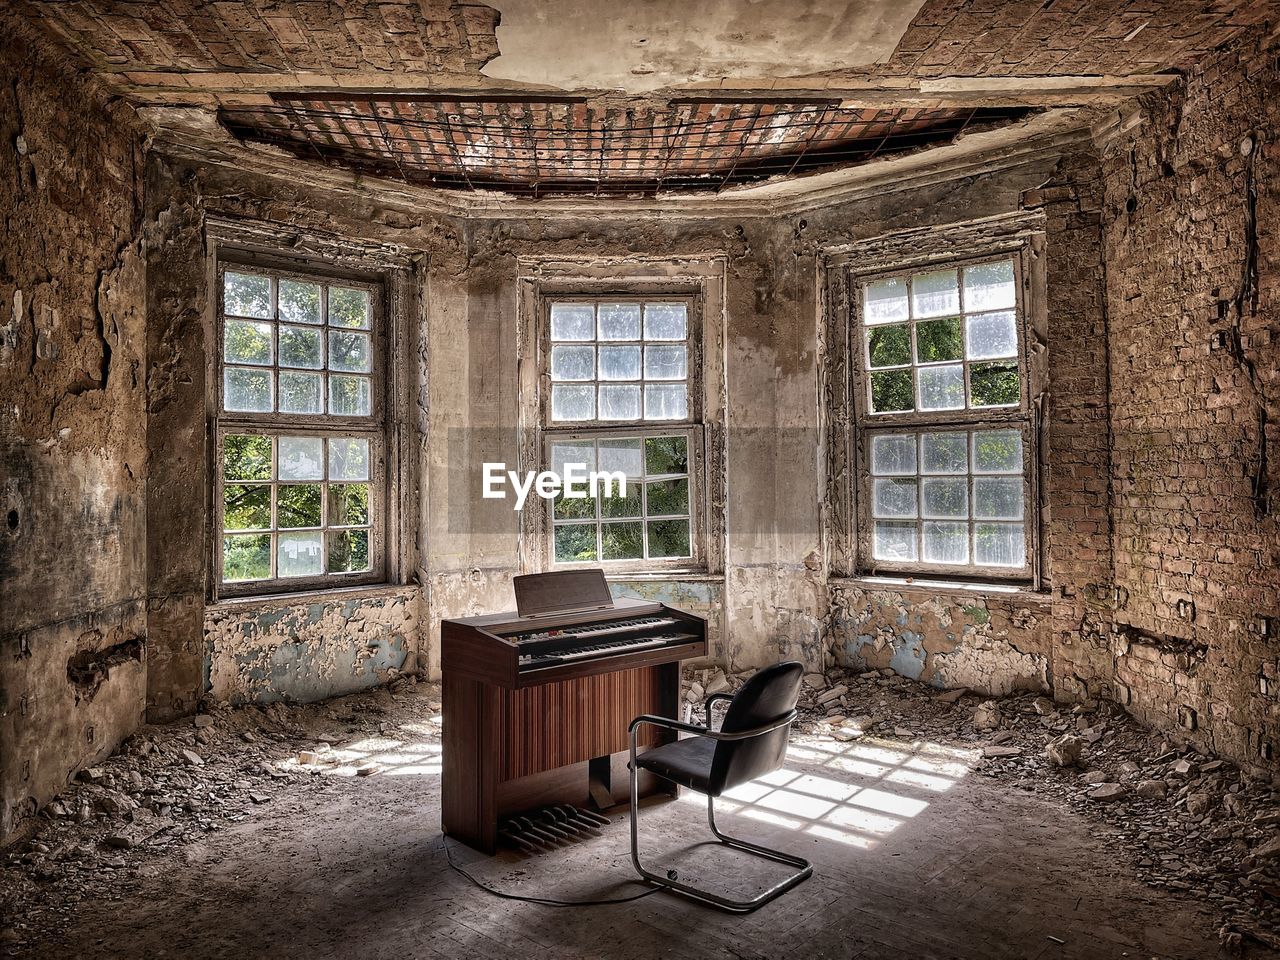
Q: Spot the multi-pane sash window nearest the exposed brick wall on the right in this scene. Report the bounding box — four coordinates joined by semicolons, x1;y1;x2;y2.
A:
852;253;1034;580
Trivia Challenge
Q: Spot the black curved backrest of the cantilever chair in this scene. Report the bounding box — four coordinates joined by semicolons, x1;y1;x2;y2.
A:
708;660;804;796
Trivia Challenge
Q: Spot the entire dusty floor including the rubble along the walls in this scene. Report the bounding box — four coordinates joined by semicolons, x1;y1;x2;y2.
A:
0;676;1277;960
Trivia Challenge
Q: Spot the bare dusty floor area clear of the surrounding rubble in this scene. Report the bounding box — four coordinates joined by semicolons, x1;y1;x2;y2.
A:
12;735;1219;960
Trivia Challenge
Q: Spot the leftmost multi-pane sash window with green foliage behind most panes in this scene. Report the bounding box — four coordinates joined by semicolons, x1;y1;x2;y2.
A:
214;262;385;595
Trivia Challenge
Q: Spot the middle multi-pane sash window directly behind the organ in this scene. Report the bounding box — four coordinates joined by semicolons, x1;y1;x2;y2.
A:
541;297;701;567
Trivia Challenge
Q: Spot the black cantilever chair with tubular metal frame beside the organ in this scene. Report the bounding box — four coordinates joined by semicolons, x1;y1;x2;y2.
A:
628;660;813;913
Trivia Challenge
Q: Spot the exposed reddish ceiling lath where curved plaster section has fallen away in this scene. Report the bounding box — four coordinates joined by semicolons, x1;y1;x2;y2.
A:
219;95;1032;197
